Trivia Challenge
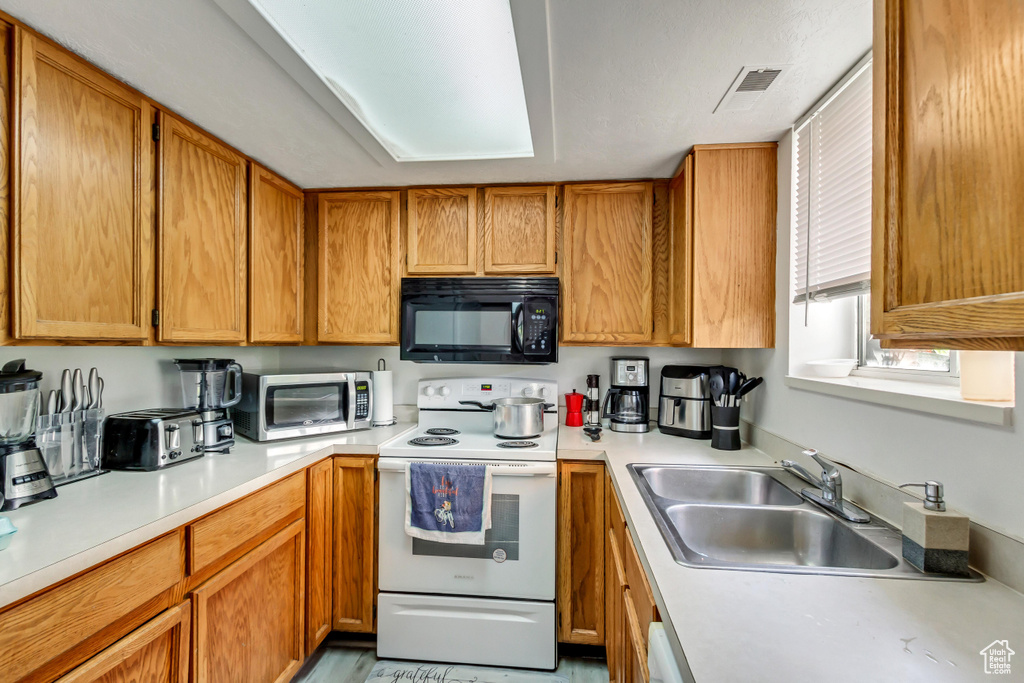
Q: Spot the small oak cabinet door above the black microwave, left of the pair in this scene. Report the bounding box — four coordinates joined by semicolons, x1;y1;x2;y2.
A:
406;187;477;275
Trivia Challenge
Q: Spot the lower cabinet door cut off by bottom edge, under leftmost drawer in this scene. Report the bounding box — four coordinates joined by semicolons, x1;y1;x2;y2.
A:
58;600;191;683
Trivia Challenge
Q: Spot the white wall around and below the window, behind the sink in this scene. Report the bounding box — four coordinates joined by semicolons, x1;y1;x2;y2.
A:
724;131;1024;540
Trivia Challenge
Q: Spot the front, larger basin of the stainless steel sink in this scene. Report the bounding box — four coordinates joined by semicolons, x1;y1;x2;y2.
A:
666;505;899;569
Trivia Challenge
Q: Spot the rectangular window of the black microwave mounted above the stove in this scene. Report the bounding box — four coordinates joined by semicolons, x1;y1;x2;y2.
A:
413;304;512;348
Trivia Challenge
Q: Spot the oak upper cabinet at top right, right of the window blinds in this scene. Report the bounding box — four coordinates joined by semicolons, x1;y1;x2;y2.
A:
871;0;1024;349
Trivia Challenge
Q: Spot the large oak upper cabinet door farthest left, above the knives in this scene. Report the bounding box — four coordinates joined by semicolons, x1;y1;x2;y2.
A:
14;29;155;341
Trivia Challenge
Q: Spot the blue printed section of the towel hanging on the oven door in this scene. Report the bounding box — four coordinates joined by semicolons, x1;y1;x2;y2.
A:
409;463;487;532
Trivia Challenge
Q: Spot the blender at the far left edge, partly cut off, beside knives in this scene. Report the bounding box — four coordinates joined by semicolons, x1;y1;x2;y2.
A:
0;358;57;510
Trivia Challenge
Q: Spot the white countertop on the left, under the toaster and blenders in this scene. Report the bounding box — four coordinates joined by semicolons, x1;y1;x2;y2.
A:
0;423;416;607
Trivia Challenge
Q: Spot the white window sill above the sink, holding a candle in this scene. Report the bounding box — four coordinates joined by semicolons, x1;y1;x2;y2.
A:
785;375;1014;427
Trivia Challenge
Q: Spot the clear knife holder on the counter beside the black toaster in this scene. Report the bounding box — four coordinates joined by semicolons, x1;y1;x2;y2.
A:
36;408;103;484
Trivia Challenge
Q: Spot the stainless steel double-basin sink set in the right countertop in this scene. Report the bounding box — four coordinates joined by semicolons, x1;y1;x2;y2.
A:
628;464;982;581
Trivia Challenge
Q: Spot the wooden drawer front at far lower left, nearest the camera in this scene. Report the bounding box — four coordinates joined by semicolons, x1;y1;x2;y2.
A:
0;531;184;681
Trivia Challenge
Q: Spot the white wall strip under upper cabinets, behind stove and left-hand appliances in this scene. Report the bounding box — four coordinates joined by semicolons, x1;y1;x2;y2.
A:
8;346;722;414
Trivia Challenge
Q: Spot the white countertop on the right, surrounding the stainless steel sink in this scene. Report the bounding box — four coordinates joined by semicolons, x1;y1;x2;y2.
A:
558;426;1024;683
